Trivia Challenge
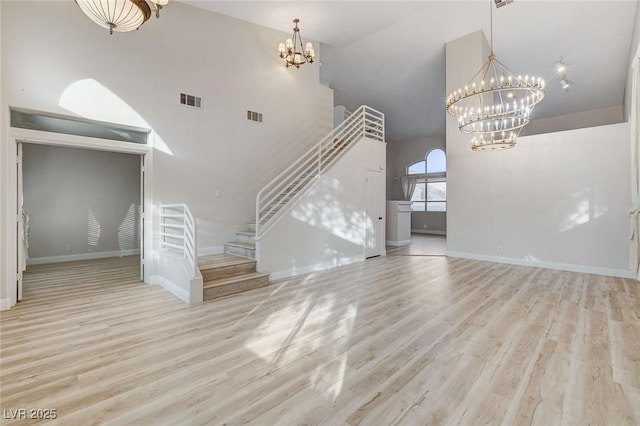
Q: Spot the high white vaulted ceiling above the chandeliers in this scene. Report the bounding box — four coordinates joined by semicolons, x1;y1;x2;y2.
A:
182;0;638;141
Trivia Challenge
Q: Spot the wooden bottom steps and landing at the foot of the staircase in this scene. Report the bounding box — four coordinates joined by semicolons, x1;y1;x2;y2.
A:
198;253;269;301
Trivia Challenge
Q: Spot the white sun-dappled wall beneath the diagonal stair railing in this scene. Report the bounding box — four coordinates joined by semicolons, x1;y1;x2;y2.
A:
258;138;386;279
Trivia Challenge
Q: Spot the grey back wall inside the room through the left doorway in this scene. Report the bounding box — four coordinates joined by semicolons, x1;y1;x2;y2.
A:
23;143;140;263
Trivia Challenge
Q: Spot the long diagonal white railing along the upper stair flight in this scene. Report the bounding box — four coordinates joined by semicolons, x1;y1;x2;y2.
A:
256;105;385;239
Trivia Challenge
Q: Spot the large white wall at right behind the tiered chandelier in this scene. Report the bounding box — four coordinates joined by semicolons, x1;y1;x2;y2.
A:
447;33;630;276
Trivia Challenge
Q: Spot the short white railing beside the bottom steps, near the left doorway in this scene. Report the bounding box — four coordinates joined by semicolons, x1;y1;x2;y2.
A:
160;204;198;278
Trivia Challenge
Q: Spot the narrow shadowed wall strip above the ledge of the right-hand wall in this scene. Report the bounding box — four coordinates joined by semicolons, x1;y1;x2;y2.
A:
521;105;625;136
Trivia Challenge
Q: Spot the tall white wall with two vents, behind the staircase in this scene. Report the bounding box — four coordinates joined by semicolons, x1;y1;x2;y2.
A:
1;2;333;256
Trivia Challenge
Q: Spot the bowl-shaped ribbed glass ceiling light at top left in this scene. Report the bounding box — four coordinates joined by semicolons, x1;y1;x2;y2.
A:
76;0;169;34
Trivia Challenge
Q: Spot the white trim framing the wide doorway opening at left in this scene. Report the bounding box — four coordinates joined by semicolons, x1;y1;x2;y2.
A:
0;127;153;309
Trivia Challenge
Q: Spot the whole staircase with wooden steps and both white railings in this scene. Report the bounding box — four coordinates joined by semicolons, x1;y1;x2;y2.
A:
159;106;384;303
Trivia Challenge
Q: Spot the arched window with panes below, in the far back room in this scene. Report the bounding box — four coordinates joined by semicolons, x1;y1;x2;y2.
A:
407;148;447;212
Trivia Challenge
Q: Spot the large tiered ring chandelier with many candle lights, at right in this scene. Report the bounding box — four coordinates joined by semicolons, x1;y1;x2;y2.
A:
446;0;545;151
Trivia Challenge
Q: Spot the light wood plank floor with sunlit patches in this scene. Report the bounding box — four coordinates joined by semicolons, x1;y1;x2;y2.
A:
0;241;640;425
